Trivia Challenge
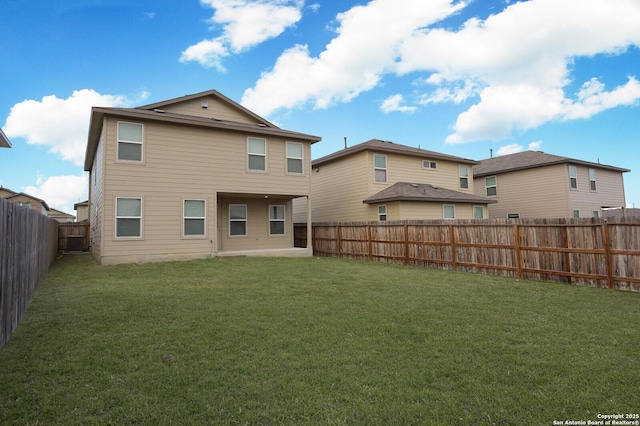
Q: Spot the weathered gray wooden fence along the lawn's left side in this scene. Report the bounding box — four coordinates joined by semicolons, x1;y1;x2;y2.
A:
0;199;58;348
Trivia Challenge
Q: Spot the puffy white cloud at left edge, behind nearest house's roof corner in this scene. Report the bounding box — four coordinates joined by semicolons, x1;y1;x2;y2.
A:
4;89;138;166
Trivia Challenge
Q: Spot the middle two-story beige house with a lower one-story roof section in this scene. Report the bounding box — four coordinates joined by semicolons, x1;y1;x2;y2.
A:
296;139;495;222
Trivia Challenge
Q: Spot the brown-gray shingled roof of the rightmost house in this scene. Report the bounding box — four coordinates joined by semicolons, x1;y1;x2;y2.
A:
473;151;629;177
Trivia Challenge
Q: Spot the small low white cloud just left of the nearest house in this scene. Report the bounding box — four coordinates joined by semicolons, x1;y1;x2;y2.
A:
22;174;89;214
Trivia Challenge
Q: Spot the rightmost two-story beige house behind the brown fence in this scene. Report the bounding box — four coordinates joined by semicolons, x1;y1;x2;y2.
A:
474;151;629;218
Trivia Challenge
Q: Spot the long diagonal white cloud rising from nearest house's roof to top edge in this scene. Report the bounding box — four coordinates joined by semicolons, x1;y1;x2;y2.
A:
242;0;462;116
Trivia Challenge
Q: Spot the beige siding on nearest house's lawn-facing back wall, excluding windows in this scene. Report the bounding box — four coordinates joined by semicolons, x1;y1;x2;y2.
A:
102;117;310;263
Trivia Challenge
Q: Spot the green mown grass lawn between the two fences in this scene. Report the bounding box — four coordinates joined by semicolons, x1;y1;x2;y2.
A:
0;255;640;425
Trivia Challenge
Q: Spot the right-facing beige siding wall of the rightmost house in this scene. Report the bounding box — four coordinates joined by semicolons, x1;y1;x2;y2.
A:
567;166;625;217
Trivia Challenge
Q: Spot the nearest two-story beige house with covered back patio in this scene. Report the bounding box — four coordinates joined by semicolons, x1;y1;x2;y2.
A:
84;90;320;264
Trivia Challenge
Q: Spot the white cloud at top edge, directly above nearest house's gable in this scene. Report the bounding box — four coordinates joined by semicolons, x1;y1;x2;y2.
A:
180;0;302;71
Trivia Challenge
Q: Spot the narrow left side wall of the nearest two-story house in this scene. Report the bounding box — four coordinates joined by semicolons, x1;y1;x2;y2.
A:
89;126;104;258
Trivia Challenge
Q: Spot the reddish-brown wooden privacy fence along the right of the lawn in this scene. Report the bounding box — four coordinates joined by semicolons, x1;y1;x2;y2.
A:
295;218;640;291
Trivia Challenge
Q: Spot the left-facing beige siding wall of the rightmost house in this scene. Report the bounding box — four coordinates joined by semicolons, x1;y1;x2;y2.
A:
475;164;569;219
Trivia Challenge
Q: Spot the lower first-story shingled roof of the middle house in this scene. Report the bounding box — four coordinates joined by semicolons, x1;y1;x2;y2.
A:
362;182;497;204
